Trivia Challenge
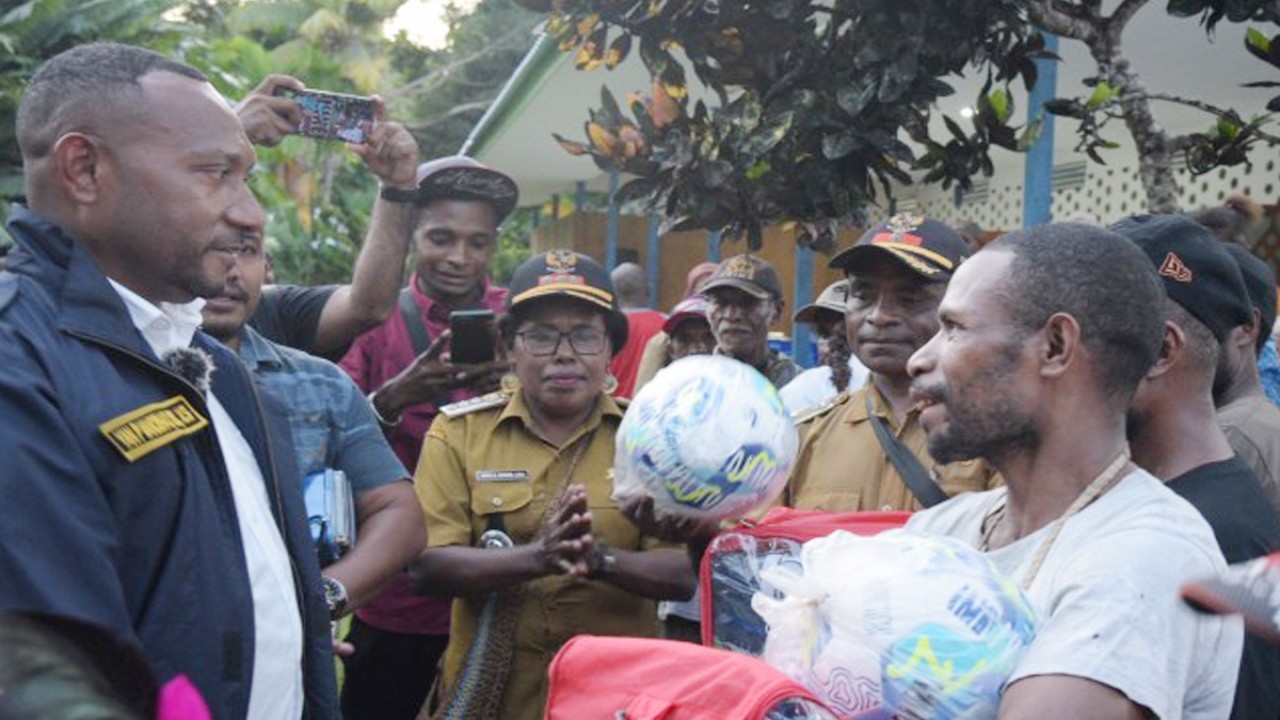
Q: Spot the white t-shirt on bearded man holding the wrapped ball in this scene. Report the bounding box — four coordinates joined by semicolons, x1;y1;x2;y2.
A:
906;470;1244;720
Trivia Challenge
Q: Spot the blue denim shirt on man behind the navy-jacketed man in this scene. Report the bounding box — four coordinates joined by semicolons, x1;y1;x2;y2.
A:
239;325;408;492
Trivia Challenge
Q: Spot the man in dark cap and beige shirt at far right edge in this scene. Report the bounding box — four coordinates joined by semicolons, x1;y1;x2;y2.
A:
1213;243;1280;512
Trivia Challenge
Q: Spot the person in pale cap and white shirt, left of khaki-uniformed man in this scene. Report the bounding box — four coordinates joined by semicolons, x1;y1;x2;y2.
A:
778;278;869;415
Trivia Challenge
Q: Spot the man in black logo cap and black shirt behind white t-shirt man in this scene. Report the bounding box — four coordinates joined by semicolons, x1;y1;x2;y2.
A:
1112;215;1280;720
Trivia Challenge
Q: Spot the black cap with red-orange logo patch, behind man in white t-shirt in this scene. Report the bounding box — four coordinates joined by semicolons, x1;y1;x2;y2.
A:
1111;215;1253;342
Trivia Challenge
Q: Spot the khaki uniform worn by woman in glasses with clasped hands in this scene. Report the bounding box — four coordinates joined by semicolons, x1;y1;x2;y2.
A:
413;393;657;720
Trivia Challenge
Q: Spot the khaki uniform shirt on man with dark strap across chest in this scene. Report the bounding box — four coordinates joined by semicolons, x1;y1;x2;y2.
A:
782;380;1002;512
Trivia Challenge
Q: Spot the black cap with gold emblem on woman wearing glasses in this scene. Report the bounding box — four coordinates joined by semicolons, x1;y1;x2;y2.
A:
507;250;627;354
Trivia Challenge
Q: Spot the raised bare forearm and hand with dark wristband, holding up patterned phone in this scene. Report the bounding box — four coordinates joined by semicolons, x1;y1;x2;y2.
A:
311;96;419;354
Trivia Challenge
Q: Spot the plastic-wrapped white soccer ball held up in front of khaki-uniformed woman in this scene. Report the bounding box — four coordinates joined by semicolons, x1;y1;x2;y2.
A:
613;355;799;519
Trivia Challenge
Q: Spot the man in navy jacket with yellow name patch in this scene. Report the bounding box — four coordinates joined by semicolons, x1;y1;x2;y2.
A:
0;45;337;719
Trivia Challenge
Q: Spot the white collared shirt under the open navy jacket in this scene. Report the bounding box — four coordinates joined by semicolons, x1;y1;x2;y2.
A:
108;278;303;720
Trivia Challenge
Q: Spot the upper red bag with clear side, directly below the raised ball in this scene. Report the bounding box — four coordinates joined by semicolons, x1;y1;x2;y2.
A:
698;507;911;656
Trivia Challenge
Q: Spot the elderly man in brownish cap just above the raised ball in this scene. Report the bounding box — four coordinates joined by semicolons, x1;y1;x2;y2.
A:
703;255;800;387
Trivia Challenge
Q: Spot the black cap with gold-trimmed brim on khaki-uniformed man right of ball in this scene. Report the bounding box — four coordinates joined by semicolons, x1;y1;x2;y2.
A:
828;213;969;282
